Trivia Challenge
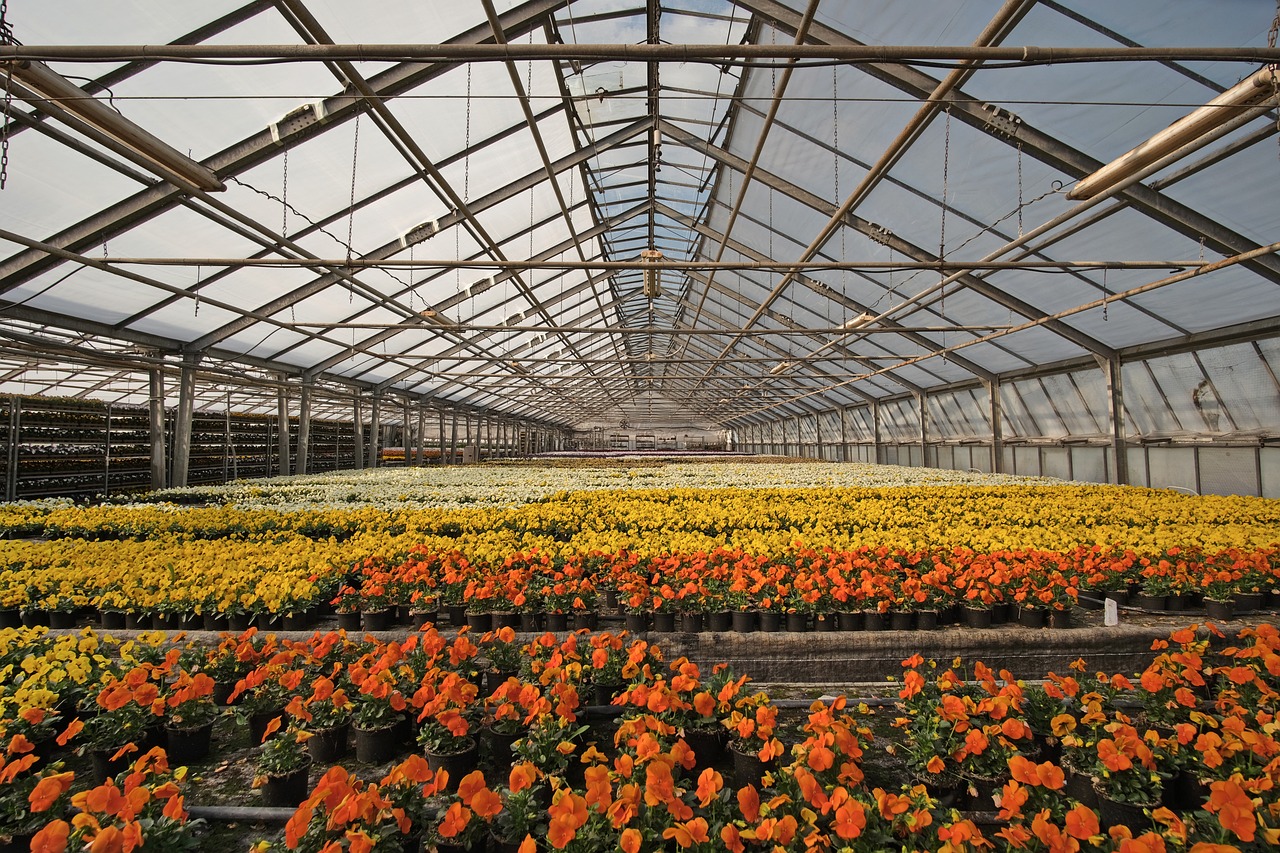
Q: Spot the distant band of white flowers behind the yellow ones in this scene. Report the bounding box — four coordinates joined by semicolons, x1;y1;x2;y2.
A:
135;457;1064;510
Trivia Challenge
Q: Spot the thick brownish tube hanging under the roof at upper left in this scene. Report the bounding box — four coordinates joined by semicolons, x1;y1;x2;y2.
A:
0;61;227;192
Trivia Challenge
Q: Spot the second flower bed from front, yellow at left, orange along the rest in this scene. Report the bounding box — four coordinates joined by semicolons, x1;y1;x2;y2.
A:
0;537;1280;630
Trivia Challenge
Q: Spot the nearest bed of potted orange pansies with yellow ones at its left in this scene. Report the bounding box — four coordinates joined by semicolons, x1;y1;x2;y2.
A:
0;617;1280;853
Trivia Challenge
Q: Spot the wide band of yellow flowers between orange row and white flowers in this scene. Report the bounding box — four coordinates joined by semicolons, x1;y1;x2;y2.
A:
0;485;1280;612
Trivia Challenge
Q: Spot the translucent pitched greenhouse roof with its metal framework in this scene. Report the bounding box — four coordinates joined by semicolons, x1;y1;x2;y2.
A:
0;0;1280;442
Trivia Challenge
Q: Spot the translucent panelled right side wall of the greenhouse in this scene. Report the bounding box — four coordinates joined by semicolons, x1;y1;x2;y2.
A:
736;327;1280;498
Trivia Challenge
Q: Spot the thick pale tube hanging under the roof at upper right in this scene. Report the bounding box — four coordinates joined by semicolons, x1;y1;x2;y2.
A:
1066;67;1276;200
